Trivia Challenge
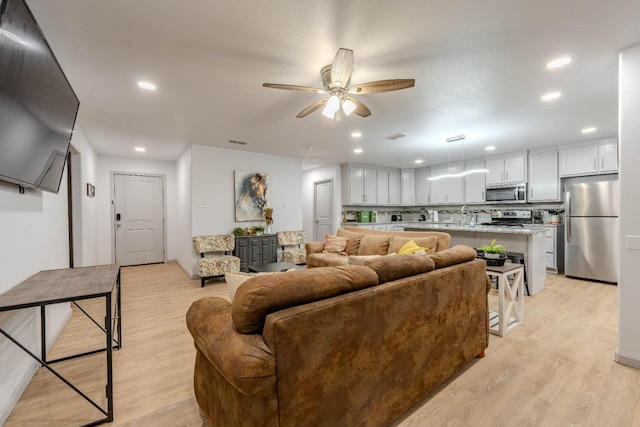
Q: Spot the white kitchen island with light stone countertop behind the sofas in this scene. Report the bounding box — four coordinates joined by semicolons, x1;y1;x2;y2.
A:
405;222;547;295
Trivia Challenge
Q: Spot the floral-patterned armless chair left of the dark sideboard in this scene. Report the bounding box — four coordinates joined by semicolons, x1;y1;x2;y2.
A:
193;234;240;288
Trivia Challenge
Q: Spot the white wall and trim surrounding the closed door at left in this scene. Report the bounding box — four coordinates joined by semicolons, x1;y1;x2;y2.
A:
95;156;178;264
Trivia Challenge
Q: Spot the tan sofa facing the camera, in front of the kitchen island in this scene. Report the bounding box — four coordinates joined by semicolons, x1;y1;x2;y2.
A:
305;227;451;268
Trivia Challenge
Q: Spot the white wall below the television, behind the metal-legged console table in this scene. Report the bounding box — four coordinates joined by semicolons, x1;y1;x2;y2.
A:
0;125;96;425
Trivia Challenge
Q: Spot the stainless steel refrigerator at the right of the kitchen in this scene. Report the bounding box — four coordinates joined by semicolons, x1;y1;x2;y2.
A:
564;181;620;283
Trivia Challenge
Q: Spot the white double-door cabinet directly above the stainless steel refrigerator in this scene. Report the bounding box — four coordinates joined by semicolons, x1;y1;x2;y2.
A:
560;140;618;177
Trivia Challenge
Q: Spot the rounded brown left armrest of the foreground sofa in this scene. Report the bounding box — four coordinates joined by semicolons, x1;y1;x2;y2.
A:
186;297;276;396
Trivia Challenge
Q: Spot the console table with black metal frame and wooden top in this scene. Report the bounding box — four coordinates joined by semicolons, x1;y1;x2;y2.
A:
0;264;122;426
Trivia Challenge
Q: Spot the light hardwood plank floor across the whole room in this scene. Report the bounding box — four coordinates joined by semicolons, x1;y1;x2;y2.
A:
6;264;640;427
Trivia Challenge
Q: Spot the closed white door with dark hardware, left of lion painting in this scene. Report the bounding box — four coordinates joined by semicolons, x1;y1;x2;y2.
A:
113;174;164;265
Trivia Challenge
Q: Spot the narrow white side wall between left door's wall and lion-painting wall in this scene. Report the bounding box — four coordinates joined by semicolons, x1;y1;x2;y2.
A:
176;147;193;275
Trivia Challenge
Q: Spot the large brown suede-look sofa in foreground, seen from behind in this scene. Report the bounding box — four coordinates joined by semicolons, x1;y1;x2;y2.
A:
186;246;489;427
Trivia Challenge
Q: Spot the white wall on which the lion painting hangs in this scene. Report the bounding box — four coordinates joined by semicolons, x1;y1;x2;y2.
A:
188;145;302;277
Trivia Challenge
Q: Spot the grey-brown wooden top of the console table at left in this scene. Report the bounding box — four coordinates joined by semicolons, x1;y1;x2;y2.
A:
0;264;120;311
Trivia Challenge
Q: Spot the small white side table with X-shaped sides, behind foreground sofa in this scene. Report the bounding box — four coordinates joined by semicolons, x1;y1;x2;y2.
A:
487;262;524;337
